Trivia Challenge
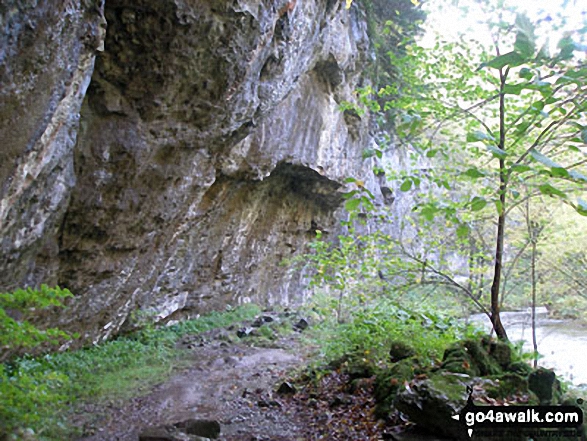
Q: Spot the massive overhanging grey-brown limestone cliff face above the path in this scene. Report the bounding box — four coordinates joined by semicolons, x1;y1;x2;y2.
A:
0;0;375;339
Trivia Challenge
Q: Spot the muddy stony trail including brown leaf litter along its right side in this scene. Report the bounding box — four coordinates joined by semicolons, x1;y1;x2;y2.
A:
76;313;450;441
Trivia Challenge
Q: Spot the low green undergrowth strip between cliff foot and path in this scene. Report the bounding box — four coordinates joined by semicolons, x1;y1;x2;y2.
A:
0;305;260;440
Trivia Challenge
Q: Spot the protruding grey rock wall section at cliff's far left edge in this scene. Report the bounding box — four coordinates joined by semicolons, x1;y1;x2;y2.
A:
0;0;105;290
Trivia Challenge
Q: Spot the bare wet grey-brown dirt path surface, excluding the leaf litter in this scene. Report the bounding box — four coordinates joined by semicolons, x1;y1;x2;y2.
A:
83;326;314;441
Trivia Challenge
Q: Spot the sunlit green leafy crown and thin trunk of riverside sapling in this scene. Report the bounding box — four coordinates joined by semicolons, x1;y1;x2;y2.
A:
360;1;587;338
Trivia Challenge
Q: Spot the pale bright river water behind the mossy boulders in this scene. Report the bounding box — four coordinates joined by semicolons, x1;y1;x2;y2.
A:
469;307;587;385
